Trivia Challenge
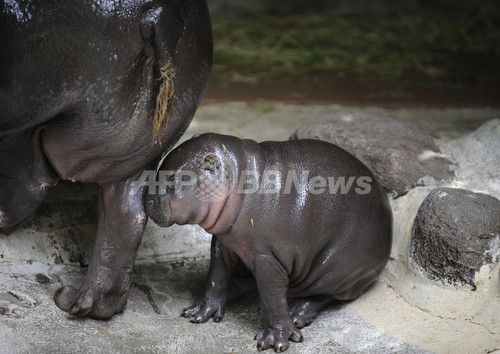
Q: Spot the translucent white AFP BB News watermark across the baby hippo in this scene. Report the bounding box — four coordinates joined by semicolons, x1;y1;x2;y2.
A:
133;170;373;199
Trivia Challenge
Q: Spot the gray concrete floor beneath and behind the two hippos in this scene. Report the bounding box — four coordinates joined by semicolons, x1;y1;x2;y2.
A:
0;103;500;353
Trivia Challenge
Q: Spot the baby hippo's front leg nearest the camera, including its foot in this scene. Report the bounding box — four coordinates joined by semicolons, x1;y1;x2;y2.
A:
254;255;302;353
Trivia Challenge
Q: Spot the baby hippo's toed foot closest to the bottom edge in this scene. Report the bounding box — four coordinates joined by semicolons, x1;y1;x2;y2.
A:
255;320;303;353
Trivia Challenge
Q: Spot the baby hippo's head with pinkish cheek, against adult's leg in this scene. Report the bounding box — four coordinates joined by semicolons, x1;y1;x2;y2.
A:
145;137;234;227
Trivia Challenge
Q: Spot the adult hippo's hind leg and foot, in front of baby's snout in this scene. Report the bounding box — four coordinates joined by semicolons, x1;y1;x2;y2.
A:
54;176;147;319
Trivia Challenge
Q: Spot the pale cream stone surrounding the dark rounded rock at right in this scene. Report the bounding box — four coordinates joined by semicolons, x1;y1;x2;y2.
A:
372;119;500;353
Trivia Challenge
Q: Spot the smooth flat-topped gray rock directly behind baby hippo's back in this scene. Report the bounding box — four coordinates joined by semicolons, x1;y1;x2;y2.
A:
290;113;453;196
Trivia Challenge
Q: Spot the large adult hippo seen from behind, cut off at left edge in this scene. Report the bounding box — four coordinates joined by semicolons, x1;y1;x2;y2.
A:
0;0;212;318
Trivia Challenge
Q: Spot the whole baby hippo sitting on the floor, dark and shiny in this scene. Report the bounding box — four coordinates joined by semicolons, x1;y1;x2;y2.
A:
146;134;392;352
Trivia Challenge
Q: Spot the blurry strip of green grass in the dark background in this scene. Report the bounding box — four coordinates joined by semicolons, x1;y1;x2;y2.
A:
212;14;500;83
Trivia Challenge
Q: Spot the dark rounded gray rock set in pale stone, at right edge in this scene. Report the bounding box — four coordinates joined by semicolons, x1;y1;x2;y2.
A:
410;188;500;290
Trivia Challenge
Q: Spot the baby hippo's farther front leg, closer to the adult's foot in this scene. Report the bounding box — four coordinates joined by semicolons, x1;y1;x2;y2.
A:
181;236;238;323
